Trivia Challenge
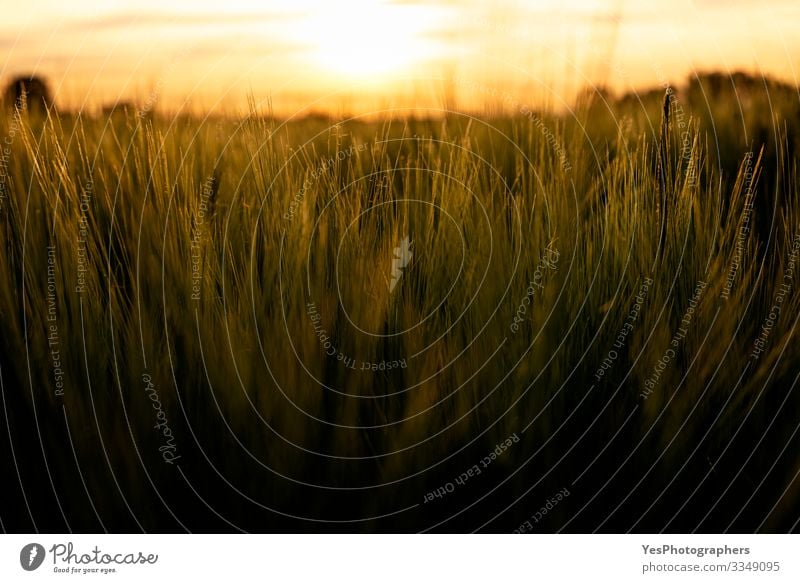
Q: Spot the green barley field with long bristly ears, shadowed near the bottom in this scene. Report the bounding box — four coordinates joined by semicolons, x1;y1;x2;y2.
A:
0;75;800;532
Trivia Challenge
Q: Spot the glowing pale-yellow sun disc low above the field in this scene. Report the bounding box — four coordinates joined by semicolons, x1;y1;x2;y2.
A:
297;0;438;78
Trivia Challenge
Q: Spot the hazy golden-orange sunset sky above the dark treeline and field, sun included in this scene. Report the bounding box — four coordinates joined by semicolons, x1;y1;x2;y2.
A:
0;0;800;114
